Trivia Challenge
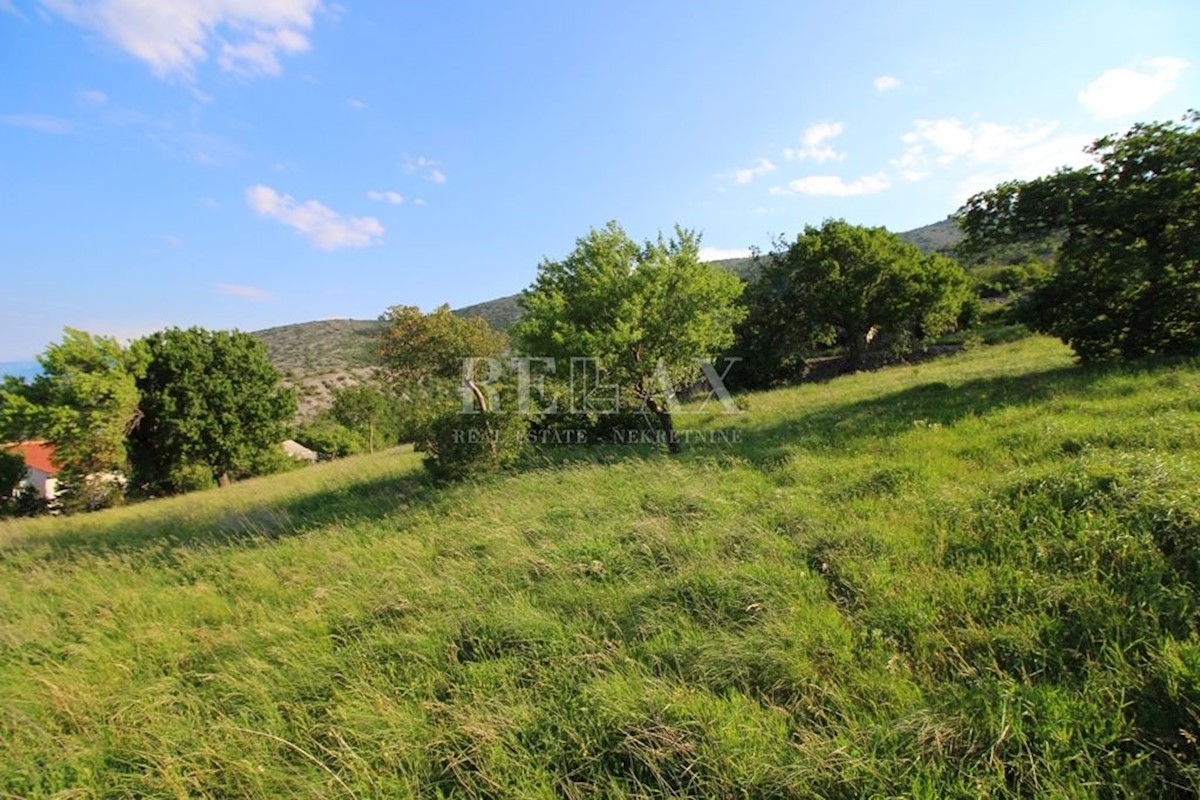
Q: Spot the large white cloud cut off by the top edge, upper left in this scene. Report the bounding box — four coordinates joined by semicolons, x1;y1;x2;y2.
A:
42;0;320;78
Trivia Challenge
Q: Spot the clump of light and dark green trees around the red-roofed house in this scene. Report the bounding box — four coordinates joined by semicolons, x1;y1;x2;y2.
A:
0;327;296;513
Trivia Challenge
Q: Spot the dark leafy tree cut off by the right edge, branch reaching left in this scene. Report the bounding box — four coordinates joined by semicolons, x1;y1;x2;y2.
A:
958;110;1200;361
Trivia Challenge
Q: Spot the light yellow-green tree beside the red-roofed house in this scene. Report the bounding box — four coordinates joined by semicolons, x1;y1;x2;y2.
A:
0;327;145;511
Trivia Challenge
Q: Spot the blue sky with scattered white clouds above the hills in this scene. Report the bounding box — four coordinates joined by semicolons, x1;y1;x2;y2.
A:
0;0;1200;361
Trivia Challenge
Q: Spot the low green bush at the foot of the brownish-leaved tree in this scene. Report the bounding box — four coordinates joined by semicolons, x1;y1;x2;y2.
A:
416;413;532;481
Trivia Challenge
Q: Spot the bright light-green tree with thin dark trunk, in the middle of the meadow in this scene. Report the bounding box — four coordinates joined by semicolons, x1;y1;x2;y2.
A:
514;222;743;452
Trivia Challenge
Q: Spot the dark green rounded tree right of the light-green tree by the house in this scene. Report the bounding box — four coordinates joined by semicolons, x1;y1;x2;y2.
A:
130;327;296;493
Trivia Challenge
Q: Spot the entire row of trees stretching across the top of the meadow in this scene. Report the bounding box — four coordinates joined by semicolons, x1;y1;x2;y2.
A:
7;112;1200;510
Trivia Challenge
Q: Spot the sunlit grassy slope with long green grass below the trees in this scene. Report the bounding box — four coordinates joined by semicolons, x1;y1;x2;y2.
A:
0;338;1200;798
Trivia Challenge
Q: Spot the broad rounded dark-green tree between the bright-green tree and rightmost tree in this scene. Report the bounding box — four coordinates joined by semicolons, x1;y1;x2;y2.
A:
739;219;971;383
